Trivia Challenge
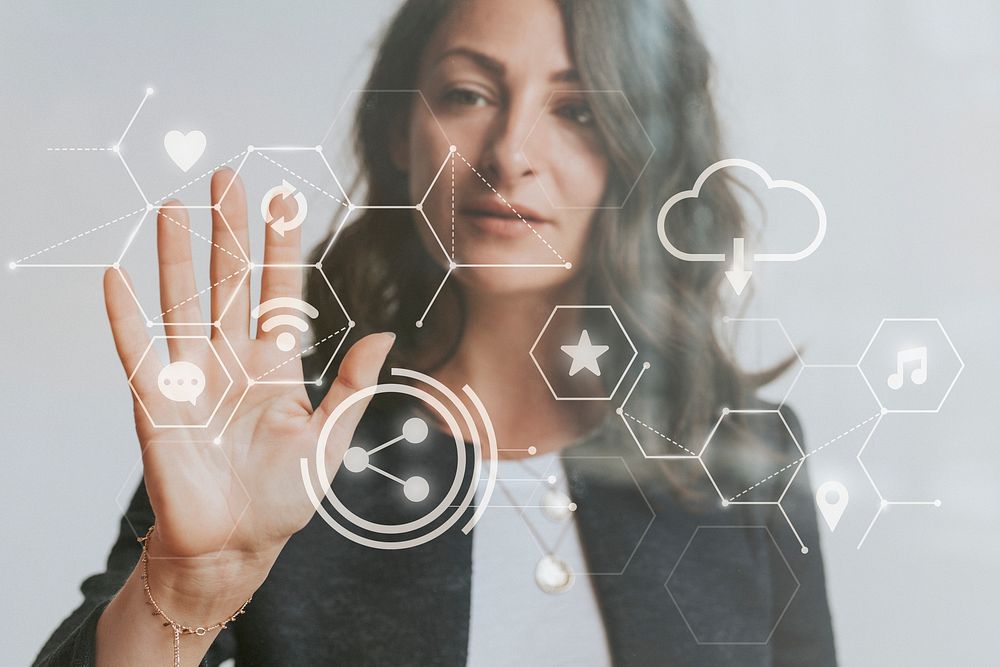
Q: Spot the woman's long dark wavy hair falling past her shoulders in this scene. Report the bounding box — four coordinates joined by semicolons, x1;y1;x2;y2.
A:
307;0;783;496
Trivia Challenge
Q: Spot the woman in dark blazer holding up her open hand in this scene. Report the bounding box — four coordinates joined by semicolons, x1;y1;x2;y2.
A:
37;0;835;665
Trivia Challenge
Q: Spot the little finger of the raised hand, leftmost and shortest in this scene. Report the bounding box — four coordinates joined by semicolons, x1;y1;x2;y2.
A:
104;269;162;414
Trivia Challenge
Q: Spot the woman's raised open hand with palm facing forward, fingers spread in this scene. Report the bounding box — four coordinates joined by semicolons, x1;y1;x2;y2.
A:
105;172;390;556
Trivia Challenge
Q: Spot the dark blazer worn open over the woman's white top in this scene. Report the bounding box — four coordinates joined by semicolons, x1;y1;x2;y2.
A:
35;396;836;666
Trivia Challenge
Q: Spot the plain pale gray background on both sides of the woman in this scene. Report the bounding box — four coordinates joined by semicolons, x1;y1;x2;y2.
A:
0;0;1000;665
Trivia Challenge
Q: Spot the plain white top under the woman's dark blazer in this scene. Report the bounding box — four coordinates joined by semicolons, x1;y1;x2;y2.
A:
468;452;611;667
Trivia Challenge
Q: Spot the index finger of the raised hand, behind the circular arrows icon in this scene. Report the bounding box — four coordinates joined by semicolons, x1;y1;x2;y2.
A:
257;189;303;348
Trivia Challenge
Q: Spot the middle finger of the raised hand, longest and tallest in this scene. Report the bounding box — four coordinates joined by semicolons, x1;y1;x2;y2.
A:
210;168;250;339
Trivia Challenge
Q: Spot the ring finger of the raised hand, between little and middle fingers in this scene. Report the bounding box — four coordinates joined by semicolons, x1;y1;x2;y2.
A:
156;200;204;361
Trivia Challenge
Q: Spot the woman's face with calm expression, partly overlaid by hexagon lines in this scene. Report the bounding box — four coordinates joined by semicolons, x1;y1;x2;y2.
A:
393;0;608;293
